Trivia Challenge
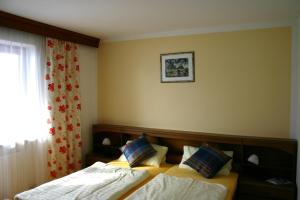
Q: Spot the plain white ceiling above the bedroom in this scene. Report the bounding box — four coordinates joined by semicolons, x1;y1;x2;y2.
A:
0;0;300;40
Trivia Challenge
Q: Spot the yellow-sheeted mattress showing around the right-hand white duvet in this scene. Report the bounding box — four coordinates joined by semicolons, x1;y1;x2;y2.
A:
165;165;238;200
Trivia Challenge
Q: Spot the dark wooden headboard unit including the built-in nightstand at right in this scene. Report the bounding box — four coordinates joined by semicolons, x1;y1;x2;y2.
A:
93;124;297;199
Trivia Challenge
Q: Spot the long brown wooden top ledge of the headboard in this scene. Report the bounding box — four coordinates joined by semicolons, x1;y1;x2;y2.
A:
93;124;297;151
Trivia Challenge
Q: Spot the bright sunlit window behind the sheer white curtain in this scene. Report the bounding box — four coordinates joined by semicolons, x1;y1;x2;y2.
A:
0;40;46;146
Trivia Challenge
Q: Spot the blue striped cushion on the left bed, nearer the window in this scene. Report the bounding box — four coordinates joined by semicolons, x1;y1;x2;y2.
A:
123;136;156;167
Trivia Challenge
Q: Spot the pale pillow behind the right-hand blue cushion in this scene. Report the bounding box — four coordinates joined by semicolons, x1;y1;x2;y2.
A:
179;146;233;176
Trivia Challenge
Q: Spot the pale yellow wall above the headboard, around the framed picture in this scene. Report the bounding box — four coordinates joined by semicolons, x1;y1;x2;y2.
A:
98;27;291;138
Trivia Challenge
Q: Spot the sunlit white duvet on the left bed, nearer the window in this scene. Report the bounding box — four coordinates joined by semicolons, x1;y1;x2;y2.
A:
15;162;149;200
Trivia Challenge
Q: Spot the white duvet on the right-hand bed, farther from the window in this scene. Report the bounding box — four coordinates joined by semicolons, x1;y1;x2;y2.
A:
126;174;227;200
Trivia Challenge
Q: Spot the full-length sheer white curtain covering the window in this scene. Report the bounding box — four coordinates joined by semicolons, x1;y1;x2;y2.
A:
0;27;48;199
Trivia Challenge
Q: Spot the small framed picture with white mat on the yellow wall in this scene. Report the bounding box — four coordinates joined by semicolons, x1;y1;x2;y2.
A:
160;51;195;83
